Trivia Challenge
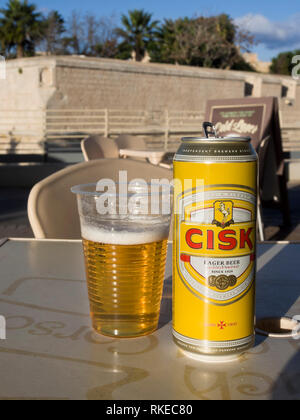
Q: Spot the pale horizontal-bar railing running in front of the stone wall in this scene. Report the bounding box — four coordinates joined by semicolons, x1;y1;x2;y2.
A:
0;109;300;152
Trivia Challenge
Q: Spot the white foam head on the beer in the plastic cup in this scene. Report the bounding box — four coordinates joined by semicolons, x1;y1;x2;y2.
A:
81;225;169;245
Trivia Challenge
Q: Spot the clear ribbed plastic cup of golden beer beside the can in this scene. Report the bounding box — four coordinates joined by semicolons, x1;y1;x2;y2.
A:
72;183;172;337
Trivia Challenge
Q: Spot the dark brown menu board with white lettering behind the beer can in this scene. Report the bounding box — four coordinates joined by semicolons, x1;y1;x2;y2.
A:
206;97;290;230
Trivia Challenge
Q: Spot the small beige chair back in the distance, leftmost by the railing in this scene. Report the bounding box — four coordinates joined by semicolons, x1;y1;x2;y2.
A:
81;136;119;162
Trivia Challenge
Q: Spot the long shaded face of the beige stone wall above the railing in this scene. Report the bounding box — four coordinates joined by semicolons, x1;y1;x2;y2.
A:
50;58;244;111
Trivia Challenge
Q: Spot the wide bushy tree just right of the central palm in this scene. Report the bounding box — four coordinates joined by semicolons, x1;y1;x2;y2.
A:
151;15;253;70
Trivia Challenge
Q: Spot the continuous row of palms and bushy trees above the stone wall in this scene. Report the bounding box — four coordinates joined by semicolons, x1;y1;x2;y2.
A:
0;0;254;71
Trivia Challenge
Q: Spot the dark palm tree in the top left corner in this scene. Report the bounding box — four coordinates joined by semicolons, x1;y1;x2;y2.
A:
0;0;43;58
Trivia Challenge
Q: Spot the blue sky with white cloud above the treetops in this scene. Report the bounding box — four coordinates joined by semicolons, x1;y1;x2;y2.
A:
0;0;300;60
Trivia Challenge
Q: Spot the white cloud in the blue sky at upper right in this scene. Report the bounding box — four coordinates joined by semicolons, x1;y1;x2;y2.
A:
235;14;300;50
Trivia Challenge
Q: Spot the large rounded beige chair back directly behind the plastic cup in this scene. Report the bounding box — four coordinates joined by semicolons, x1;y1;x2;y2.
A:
28;159;173;239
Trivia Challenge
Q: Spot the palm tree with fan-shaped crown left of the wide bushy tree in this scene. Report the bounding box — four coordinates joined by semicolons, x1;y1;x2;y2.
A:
116;10;158;61
